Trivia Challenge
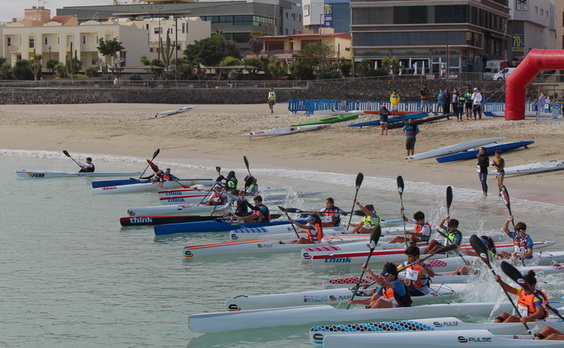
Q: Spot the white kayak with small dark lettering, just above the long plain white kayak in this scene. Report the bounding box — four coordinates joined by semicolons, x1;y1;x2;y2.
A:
225;284;466;311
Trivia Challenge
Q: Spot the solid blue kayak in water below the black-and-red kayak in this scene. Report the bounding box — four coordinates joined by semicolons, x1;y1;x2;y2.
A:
154;220;306;236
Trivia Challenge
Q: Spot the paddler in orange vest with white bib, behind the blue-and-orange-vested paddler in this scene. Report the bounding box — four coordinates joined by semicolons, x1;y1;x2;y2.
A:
398;245;435;296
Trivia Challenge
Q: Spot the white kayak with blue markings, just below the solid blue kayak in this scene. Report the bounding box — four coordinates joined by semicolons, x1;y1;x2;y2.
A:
230;224;413;242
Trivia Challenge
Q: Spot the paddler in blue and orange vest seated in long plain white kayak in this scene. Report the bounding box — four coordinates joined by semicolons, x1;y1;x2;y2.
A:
348;262;412;308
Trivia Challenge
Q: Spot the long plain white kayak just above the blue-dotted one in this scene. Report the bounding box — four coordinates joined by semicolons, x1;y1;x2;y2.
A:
188;302;516;334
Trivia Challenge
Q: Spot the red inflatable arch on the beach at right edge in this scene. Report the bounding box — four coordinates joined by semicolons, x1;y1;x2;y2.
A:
505;49;564;121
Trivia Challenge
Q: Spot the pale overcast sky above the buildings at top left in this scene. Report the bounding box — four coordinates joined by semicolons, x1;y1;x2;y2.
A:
0;0;110;22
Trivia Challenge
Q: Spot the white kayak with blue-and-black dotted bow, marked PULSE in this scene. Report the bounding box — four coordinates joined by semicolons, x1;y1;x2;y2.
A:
309;317;564;347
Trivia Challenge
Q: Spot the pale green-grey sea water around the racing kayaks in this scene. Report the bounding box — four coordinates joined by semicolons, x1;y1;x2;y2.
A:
0;150;564;347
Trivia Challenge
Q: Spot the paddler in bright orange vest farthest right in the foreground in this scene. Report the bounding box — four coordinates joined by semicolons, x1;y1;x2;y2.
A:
494;270;549;323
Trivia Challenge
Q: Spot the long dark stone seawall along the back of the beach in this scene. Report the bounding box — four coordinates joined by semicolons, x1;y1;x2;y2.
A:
0;78;536;104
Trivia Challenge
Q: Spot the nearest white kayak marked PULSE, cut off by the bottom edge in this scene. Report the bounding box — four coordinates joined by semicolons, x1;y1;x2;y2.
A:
323;325;564;348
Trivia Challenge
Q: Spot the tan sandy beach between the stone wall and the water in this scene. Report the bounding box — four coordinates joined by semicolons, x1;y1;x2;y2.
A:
0;103;564;205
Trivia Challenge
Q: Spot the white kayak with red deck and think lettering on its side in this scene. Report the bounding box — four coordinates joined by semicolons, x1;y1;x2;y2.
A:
301;241;555;265
